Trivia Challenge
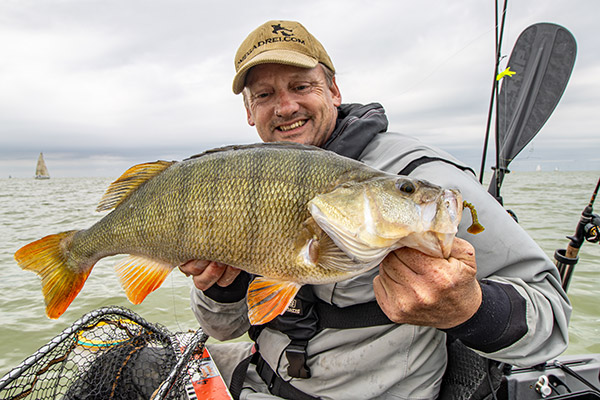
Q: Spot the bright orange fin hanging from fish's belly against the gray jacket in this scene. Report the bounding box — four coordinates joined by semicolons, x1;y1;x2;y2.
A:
247;277;302;325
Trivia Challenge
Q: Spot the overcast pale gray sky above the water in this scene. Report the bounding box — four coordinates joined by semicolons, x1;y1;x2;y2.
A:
0;0;600;178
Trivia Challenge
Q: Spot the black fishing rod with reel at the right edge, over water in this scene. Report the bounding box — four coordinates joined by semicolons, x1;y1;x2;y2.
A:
554;178;600;292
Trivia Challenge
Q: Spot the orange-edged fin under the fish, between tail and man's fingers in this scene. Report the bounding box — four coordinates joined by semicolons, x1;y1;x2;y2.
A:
115;256;175;304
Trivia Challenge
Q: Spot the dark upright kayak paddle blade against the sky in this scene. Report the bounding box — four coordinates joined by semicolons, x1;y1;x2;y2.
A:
488;23;577;196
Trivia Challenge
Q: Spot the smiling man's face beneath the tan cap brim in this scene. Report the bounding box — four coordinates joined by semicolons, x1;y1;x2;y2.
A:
245;64;342;146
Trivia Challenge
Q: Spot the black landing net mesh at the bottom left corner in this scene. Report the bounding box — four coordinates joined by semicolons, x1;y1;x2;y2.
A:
0;307;207;400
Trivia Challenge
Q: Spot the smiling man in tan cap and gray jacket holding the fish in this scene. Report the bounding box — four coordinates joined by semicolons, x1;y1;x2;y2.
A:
181;21;570;399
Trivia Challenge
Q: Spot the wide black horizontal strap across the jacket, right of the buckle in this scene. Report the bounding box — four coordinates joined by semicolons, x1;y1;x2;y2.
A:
316;301;394;329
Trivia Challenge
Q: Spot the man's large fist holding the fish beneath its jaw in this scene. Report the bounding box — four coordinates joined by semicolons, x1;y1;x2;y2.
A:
373;238;481;329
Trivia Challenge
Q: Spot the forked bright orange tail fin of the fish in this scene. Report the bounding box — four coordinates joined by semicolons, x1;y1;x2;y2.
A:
15;231;94;319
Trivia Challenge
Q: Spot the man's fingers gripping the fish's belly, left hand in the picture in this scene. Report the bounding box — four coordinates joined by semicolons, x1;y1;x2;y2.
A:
179;260;241;290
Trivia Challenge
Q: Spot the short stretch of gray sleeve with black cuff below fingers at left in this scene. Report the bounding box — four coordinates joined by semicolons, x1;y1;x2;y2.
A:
190;272;250;340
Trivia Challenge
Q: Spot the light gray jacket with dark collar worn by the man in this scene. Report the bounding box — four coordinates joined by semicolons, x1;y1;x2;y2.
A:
192;104;571;399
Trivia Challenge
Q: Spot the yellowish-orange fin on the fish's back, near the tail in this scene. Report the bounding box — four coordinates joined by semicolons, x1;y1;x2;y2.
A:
96;160;177;211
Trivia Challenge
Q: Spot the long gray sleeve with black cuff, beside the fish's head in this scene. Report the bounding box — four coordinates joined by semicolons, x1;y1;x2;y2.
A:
361;132;571;366
